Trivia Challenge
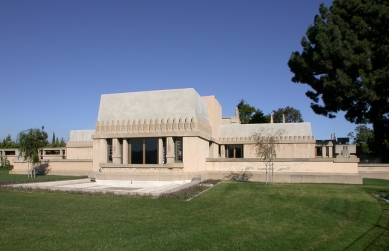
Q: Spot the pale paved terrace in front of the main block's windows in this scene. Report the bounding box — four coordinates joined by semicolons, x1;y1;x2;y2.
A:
10;179;200;197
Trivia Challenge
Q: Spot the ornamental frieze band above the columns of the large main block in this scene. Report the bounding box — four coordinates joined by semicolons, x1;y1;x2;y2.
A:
95;118;211;135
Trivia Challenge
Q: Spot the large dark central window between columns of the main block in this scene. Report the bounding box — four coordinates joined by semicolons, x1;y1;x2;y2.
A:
129;139;158;164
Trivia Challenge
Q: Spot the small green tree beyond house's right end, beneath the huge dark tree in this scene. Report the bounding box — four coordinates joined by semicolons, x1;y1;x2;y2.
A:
348;125;374;154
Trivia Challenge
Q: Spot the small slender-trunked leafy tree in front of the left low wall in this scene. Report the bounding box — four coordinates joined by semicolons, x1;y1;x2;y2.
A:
17;126;48;177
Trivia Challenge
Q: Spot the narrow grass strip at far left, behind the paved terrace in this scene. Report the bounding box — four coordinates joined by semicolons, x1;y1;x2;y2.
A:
0;170;87;185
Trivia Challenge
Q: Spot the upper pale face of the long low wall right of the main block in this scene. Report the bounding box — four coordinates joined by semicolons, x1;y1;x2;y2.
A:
206;159;358;174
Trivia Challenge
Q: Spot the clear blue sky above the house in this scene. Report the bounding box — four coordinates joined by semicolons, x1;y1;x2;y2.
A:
0;0;355;141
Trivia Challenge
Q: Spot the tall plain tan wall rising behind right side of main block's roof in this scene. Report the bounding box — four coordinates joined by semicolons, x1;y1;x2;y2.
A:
202;96;222;139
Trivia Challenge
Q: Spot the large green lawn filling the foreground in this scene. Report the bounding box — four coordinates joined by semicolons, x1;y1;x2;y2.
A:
0;177;389;250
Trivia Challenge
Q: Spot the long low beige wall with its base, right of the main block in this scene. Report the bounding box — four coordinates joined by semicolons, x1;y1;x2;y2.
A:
205;158;363;184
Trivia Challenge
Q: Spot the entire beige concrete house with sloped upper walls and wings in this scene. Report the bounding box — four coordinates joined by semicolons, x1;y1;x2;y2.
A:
6;88;362;184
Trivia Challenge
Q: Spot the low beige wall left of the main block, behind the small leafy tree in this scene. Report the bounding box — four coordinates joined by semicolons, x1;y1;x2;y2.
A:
9;159;93;176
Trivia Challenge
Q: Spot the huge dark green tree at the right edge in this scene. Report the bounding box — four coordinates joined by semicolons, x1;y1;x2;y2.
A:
288;0;389;161
